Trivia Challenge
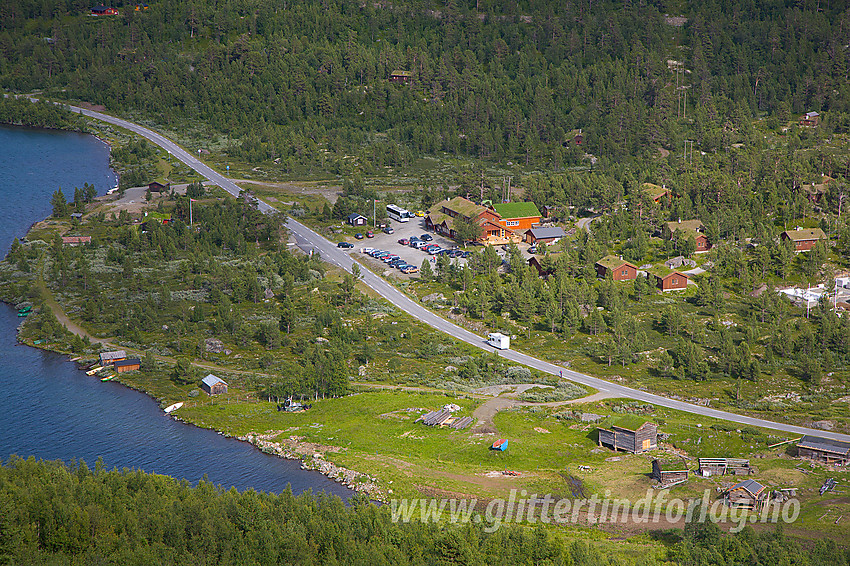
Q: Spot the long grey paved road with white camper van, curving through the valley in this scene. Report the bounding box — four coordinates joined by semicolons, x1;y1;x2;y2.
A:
64;106;850;442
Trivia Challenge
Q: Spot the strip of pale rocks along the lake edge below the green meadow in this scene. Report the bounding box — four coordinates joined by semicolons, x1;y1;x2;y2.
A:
237;430;392;501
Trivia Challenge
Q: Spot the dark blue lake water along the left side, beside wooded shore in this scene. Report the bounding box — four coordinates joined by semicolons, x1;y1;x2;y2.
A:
0;126;353;498
